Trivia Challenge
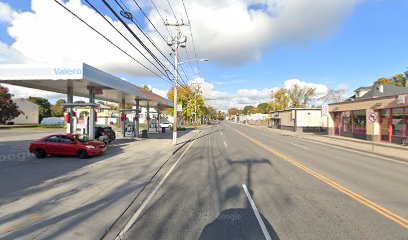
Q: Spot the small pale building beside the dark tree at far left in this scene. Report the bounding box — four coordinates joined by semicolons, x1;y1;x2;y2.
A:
7;98;40;125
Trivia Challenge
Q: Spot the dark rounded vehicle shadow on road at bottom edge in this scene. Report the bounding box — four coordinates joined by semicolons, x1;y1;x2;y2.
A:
198;208;279;240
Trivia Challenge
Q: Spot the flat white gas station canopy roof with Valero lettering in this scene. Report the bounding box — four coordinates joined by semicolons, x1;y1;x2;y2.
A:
0;63;173;108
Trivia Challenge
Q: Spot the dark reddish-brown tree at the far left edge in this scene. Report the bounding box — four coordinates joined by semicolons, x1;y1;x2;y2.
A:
0;85;22;124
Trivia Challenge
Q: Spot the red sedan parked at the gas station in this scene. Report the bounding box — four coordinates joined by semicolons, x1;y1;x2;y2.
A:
30;134;107;158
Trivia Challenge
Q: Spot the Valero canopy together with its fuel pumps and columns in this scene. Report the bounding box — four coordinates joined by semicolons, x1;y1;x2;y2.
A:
0;63;173;139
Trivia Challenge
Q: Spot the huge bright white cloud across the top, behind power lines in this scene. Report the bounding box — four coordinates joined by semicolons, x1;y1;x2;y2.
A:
0;0;359;72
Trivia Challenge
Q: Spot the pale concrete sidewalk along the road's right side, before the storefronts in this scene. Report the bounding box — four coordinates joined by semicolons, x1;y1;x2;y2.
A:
241;125;408;162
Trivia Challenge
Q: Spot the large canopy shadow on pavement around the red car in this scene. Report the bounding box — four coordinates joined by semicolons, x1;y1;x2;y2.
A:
0;139;134;204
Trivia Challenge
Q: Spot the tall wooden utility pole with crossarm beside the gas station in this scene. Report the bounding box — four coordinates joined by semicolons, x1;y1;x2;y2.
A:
164;21;190;146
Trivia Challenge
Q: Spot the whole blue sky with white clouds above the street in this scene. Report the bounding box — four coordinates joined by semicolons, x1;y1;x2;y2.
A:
0;0;408;110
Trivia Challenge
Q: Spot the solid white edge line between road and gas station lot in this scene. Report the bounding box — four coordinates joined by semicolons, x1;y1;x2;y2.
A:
115;132;201;240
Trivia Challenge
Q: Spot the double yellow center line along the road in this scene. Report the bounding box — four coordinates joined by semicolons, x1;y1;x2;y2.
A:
231;127;408;229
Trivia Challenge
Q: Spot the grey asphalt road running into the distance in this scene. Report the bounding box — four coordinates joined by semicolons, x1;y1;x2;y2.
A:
126;123;408;239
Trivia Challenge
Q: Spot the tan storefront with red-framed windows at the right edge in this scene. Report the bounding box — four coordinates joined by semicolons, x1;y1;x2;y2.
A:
328;86;408;145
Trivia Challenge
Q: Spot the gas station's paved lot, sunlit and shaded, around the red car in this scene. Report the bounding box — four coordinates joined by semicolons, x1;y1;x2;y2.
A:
0;126;196;239
